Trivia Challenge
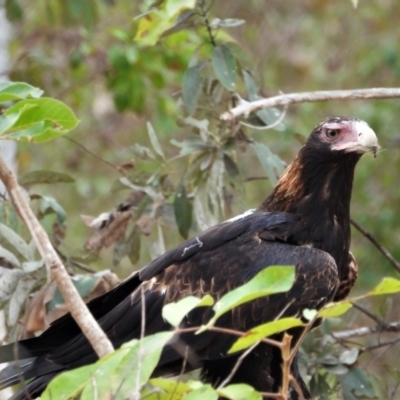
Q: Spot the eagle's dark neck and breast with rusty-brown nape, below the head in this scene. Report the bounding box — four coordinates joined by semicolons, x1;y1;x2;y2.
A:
259;148;360;280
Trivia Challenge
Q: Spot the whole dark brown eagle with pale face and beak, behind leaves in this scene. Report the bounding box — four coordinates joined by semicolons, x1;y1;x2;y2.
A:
0;117;378;400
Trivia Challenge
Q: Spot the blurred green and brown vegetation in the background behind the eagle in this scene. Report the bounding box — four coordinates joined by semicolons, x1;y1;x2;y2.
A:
0;0;400;399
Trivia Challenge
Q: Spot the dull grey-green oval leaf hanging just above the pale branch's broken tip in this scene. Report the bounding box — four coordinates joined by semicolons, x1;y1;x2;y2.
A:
211;45;236;91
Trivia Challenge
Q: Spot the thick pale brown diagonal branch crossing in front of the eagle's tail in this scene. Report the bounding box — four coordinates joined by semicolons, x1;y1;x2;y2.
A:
0;157;114;358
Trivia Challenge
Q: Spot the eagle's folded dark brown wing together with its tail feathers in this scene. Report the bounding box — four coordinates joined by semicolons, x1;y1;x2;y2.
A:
0;211;338;393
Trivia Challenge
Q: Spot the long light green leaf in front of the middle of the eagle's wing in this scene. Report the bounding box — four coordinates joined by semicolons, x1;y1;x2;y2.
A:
207;266;295;326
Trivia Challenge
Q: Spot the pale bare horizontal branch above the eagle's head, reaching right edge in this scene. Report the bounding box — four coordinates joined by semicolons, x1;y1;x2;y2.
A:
220;88;400;121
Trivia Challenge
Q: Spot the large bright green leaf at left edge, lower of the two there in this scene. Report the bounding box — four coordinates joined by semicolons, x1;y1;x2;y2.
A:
0;98;79;143
